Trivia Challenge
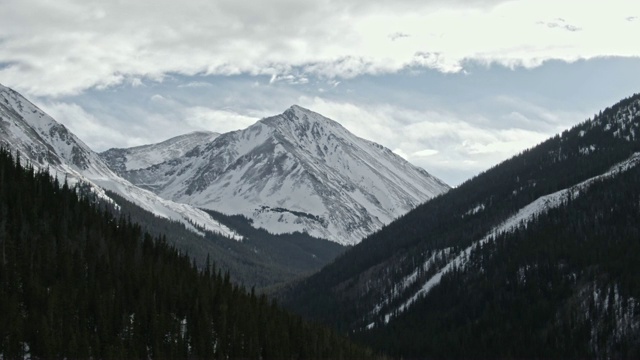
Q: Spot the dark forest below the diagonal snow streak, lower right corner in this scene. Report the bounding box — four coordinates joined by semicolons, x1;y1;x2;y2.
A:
358;151;640;359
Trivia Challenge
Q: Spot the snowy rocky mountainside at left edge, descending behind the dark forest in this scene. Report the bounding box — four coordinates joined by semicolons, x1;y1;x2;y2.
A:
0;85;239;239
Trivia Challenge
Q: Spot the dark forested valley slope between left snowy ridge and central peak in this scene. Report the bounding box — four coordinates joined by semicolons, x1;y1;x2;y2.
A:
107;191;346;291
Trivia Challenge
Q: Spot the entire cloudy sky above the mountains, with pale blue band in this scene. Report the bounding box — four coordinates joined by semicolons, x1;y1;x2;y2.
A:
0;0;640;185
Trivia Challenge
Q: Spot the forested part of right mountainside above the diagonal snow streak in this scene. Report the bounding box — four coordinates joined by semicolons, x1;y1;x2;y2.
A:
281;94;640;331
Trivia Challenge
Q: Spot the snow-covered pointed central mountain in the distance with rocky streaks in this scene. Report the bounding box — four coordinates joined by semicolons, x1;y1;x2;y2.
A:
101;105;449;244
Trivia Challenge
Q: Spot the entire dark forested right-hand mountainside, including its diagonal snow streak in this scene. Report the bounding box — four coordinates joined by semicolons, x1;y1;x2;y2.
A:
281;95;640;358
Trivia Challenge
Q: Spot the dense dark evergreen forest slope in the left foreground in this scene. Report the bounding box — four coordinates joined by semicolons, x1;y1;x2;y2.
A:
0;149;371;359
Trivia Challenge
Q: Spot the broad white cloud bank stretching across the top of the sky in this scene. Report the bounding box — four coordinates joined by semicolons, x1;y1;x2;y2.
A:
0;0;640;96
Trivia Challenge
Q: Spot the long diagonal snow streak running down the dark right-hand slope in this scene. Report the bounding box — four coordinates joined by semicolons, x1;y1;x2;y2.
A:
378;153;640;328
